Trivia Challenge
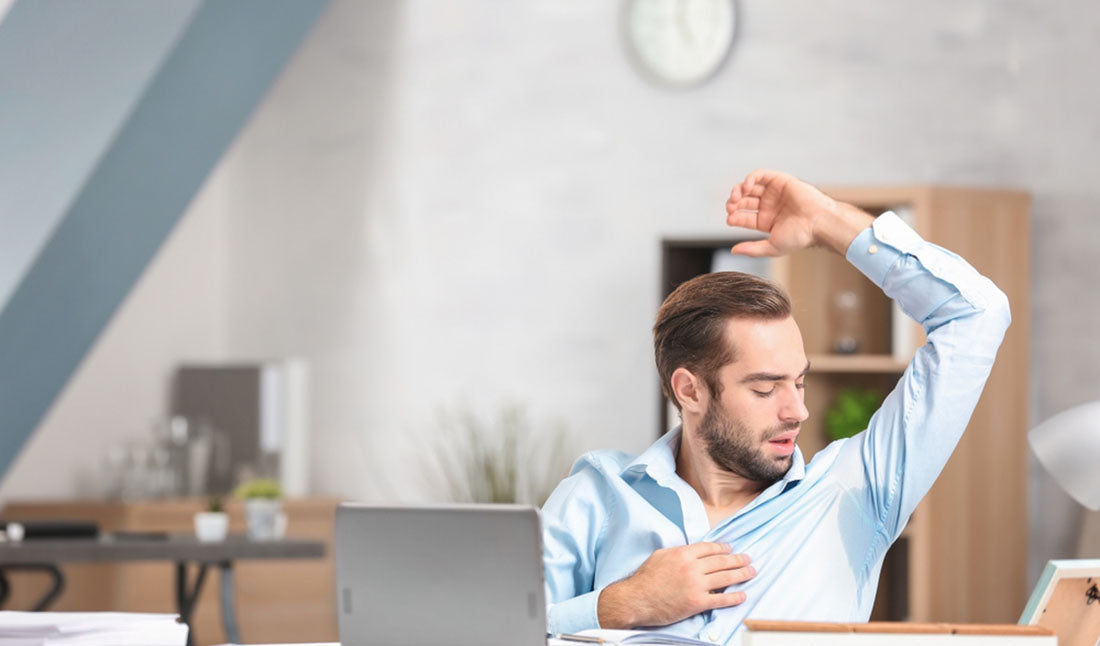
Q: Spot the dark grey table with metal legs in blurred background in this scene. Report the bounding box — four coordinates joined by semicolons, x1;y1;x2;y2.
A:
0;535;325;642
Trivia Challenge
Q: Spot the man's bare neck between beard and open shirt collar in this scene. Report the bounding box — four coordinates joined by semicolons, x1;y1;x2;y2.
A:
677;419;767;526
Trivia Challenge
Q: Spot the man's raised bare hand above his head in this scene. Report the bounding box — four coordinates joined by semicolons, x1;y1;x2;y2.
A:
726;169;872;256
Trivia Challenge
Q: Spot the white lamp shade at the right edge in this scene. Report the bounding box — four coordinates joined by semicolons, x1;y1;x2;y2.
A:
1027;402;1100;511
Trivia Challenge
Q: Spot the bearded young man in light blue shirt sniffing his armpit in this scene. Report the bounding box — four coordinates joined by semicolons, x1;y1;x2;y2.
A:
542;171;1010;644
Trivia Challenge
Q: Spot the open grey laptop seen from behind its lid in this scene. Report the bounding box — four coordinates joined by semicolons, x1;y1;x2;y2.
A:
336;503;546;646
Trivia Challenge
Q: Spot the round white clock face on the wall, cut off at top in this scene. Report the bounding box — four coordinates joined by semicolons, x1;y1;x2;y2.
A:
624;0;737;86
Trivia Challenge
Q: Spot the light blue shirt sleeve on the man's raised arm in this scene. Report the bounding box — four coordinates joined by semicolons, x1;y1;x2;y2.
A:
846;211;1011;541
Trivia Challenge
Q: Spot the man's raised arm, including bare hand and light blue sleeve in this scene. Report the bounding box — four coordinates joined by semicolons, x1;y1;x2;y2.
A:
726;171;1011;540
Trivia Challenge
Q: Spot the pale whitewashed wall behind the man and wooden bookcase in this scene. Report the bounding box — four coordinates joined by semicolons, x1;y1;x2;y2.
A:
0;0;1100;585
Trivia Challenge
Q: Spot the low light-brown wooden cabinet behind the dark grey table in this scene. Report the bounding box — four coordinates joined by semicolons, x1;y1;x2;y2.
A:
3;499;338;646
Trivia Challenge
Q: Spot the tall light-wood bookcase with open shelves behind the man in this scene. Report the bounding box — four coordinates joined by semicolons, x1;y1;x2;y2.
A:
658;186;1031;623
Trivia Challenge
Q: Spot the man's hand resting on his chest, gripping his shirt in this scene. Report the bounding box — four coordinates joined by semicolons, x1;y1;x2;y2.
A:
596;543;756;628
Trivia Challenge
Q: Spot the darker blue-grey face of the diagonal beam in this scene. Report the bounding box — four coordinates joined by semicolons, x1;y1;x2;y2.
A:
0;0;327;472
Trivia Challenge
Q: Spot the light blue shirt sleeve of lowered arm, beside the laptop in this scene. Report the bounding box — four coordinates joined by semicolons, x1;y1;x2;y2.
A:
541;458;609;634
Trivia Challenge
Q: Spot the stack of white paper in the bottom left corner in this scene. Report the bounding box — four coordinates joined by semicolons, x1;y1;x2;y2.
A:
0;611;187;646
